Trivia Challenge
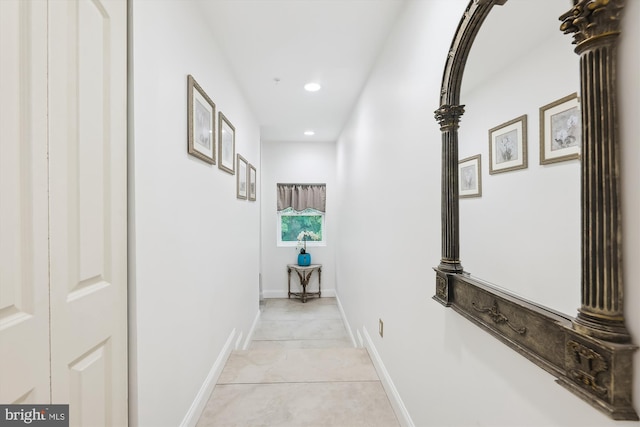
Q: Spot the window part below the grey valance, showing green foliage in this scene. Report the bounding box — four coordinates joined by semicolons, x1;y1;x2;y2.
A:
278;208;326;246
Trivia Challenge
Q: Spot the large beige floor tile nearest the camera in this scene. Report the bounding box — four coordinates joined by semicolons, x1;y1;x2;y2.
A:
198;381;399;427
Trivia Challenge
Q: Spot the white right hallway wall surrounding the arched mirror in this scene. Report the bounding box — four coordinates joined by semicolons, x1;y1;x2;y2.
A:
336;0;640;427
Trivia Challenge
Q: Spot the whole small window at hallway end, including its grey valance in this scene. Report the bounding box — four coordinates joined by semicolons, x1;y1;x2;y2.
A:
277;184;326;246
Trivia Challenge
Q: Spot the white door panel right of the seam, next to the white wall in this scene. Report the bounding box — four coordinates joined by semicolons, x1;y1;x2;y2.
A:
47;0;127;427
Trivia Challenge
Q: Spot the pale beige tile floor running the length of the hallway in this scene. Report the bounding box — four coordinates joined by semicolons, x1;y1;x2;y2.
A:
198;298;399;427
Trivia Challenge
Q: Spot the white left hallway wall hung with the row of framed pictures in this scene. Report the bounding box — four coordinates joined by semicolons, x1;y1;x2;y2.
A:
129;1;261;427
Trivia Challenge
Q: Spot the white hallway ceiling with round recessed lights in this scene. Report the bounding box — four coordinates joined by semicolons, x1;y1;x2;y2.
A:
200;0;404;142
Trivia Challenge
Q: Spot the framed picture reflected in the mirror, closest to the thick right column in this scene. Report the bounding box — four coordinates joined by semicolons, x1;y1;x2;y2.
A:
540;93;582;165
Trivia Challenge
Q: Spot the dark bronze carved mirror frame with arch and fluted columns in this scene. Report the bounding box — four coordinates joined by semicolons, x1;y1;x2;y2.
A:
433;0;638;420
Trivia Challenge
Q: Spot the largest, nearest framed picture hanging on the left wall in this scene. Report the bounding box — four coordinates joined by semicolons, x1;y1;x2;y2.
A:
187;75;216;165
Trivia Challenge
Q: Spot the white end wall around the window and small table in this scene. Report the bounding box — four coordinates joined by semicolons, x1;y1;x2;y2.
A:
260;141;339;298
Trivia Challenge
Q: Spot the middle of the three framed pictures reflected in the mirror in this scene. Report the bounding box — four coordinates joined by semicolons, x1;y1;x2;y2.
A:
489;114;527;175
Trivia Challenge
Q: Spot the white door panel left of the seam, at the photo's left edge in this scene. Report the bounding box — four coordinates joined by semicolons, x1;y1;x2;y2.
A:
0;0;50;404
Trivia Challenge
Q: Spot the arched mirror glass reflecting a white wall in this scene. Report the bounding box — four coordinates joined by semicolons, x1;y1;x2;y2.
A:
458;0;581;315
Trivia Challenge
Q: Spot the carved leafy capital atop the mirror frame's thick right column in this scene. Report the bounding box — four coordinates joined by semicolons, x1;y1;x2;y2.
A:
560;0;624;44
